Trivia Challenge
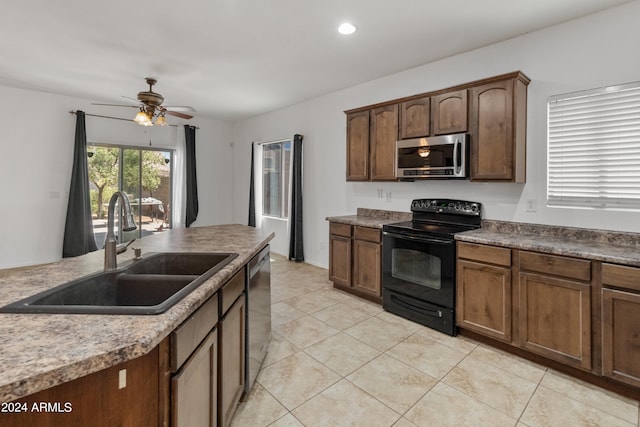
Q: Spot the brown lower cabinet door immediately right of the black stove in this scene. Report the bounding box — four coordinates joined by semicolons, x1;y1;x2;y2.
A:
456;261;511;342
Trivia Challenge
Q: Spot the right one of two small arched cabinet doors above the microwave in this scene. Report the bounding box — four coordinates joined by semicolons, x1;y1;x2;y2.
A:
433;89;468;135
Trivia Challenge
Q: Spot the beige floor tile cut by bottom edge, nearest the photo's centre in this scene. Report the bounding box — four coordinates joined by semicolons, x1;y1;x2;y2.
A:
293;380;400;427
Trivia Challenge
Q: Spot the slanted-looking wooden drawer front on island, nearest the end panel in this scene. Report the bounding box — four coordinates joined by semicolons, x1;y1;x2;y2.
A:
170;294;218;372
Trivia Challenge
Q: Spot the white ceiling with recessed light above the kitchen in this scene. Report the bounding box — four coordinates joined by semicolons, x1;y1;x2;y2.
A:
0;0;629;119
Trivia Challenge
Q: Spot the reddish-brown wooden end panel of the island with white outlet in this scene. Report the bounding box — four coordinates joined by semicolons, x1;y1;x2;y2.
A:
0;347;162;427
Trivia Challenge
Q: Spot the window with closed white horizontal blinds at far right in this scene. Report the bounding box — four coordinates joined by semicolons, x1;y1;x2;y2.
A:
547;82;640;209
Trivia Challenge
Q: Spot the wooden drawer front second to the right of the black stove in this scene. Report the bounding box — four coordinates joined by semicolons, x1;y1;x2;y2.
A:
520;251;591;282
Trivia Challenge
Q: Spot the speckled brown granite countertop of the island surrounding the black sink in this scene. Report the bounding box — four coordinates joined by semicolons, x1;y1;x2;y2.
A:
0;225;274;402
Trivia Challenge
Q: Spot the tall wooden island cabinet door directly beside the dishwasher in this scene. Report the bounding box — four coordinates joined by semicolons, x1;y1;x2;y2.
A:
218;295;246;427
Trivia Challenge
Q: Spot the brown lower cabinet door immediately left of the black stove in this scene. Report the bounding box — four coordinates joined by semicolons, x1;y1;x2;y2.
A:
353;240;382;297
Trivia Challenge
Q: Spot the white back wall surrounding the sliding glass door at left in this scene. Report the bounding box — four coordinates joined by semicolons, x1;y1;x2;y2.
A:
0;86;232;268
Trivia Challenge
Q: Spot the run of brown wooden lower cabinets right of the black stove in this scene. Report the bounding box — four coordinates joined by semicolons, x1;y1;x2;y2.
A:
456;242;640;399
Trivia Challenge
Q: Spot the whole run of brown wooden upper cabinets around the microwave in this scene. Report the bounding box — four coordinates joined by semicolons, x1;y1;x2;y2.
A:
345;71;530;183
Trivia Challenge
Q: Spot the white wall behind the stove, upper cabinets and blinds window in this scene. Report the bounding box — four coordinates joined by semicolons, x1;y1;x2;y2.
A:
233;1;640;267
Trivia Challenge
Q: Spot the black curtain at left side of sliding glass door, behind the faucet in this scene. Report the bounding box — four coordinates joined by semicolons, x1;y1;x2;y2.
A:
62;111;98;258
